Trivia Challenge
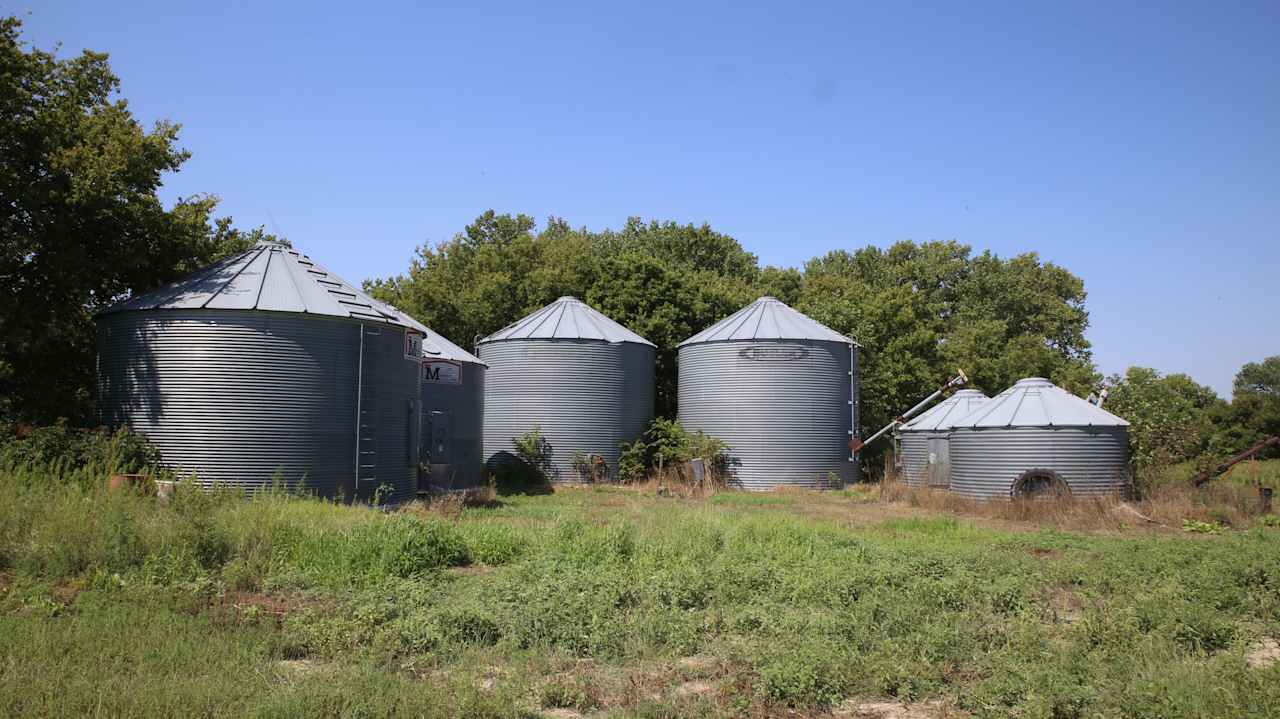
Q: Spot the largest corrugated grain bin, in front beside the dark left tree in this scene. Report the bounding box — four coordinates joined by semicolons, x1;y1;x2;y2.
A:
97;237;421;502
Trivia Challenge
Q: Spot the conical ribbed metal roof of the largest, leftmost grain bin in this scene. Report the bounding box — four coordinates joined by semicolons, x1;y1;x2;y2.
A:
102;242;411;326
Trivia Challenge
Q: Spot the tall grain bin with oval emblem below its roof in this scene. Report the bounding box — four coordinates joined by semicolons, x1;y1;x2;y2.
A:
678;297;858;490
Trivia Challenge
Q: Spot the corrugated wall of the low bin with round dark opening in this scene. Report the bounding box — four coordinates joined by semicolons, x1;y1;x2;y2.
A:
950;426;1129;499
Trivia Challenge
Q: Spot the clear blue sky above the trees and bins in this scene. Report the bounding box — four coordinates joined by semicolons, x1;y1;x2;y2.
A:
15;0;1280;395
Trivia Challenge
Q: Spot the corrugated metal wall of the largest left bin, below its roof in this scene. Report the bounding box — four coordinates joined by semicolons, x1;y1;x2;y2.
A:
97;310;419;502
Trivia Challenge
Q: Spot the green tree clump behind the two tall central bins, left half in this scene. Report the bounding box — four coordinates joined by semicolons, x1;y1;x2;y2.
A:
365;210;757;416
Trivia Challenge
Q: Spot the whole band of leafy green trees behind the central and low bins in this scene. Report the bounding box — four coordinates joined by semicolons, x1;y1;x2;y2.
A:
366;210;1096;455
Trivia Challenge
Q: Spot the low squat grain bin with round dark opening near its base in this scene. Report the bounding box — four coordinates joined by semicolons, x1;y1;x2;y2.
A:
950;377;1129;499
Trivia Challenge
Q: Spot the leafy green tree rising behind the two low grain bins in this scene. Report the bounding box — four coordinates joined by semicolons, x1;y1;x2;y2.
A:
796;242;1096;454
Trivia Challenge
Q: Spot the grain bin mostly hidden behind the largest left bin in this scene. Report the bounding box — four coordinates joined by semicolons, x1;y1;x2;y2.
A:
391;310;488;491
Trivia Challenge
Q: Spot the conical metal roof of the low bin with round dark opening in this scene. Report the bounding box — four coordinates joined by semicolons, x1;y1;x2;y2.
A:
951;377;1129;429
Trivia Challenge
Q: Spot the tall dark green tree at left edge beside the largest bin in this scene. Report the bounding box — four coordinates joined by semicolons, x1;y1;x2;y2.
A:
0;17;270;422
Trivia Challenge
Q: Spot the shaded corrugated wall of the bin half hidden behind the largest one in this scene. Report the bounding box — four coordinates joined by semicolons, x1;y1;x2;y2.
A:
421;361;486;491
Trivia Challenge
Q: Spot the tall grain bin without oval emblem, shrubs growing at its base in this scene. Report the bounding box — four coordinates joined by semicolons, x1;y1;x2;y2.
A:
479;297;654;481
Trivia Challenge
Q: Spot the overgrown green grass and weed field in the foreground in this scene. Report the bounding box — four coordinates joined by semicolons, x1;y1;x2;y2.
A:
0;460;1280;718
